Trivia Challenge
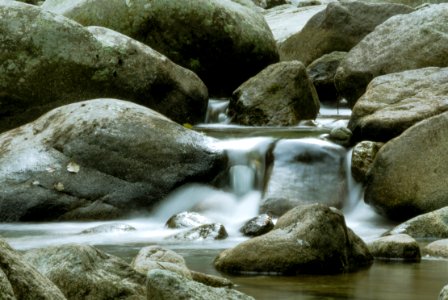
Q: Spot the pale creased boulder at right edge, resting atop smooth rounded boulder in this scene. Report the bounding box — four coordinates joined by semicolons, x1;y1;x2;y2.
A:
348;67;448;142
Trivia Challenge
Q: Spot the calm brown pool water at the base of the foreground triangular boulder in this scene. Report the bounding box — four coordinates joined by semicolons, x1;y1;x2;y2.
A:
176;249;448;300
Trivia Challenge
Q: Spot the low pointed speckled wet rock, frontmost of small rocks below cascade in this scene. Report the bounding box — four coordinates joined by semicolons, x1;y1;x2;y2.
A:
168;223;228;241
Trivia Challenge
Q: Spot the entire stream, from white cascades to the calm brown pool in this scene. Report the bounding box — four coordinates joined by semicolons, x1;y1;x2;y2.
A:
0;100;448;300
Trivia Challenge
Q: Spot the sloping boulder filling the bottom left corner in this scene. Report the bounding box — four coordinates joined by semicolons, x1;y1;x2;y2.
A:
0;239;66;300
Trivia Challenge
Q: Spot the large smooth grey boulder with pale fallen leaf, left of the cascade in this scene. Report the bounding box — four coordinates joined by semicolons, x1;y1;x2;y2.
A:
0;99;226;222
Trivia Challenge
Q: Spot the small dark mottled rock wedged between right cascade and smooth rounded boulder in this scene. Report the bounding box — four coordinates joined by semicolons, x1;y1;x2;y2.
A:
351;141;384;182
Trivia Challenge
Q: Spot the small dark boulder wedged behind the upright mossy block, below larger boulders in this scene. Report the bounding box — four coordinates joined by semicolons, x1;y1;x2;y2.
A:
306;51;347;103
